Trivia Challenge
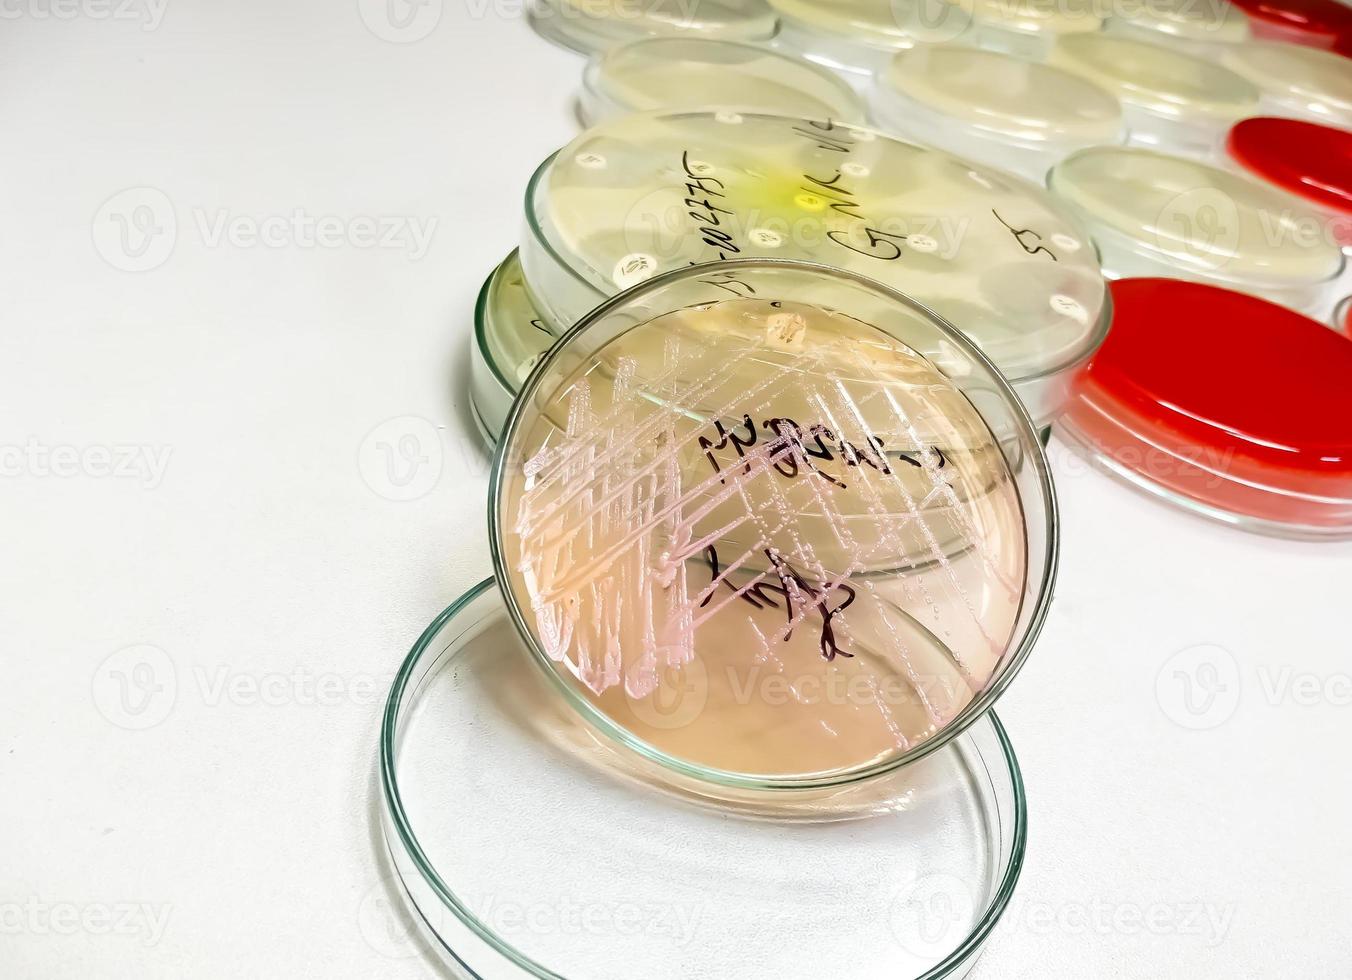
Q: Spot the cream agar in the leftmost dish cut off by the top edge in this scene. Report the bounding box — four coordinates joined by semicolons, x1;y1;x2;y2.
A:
546;0;775;41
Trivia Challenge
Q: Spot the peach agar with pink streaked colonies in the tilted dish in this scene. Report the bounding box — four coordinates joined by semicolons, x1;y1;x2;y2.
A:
498;294;1028;776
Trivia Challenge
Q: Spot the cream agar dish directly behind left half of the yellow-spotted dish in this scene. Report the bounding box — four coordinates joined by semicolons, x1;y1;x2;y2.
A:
579;38;864;126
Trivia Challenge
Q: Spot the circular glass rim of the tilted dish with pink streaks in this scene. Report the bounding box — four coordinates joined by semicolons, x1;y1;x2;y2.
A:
488;258;1060;792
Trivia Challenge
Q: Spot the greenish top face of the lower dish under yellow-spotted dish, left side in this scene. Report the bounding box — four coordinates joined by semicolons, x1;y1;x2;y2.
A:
475;250;556;392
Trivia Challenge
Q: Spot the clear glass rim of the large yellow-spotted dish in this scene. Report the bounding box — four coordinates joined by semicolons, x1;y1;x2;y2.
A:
523;111;1113;384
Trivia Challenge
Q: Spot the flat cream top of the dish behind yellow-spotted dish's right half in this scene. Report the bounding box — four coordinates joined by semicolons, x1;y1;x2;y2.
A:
880;45;1122;145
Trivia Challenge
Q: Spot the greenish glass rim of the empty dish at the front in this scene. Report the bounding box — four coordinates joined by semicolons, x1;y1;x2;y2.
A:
377;577;1028;980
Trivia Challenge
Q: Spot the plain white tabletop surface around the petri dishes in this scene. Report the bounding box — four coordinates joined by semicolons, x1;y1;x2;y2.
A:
0;0;1352;980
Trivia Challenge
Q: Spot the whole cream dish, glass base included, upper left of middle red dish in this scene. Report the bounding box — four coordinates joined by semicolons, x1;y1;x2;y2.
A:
1048;34;1259;158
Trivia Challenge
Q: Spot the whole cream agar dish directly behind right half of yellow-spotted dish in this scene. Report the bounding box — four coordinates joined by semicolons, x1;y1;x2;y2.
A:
872;45;1125;184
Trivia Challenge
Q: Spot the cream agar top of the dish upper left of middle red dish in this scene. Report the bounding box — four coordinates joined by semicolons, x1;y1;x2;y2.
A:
1048;34;1259;122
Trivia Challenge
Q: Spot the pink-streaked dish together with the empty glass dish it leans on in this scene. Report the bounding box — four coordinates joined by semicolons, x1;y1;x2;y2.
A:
394;258;1057;980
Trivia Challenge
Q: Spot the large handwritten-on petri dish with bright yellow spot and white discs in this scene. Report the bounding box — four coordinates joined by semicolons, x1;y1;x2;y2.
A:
522;112;1111;424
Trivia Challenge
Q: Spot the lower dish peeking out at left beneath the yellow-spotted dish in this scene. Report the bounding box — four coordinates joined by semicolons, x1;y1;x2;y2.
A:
469;250;556;446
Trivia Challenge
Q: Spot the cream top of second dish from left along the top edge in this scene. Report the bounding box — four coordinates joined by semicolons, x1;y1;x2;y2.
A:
769;0;971;50
